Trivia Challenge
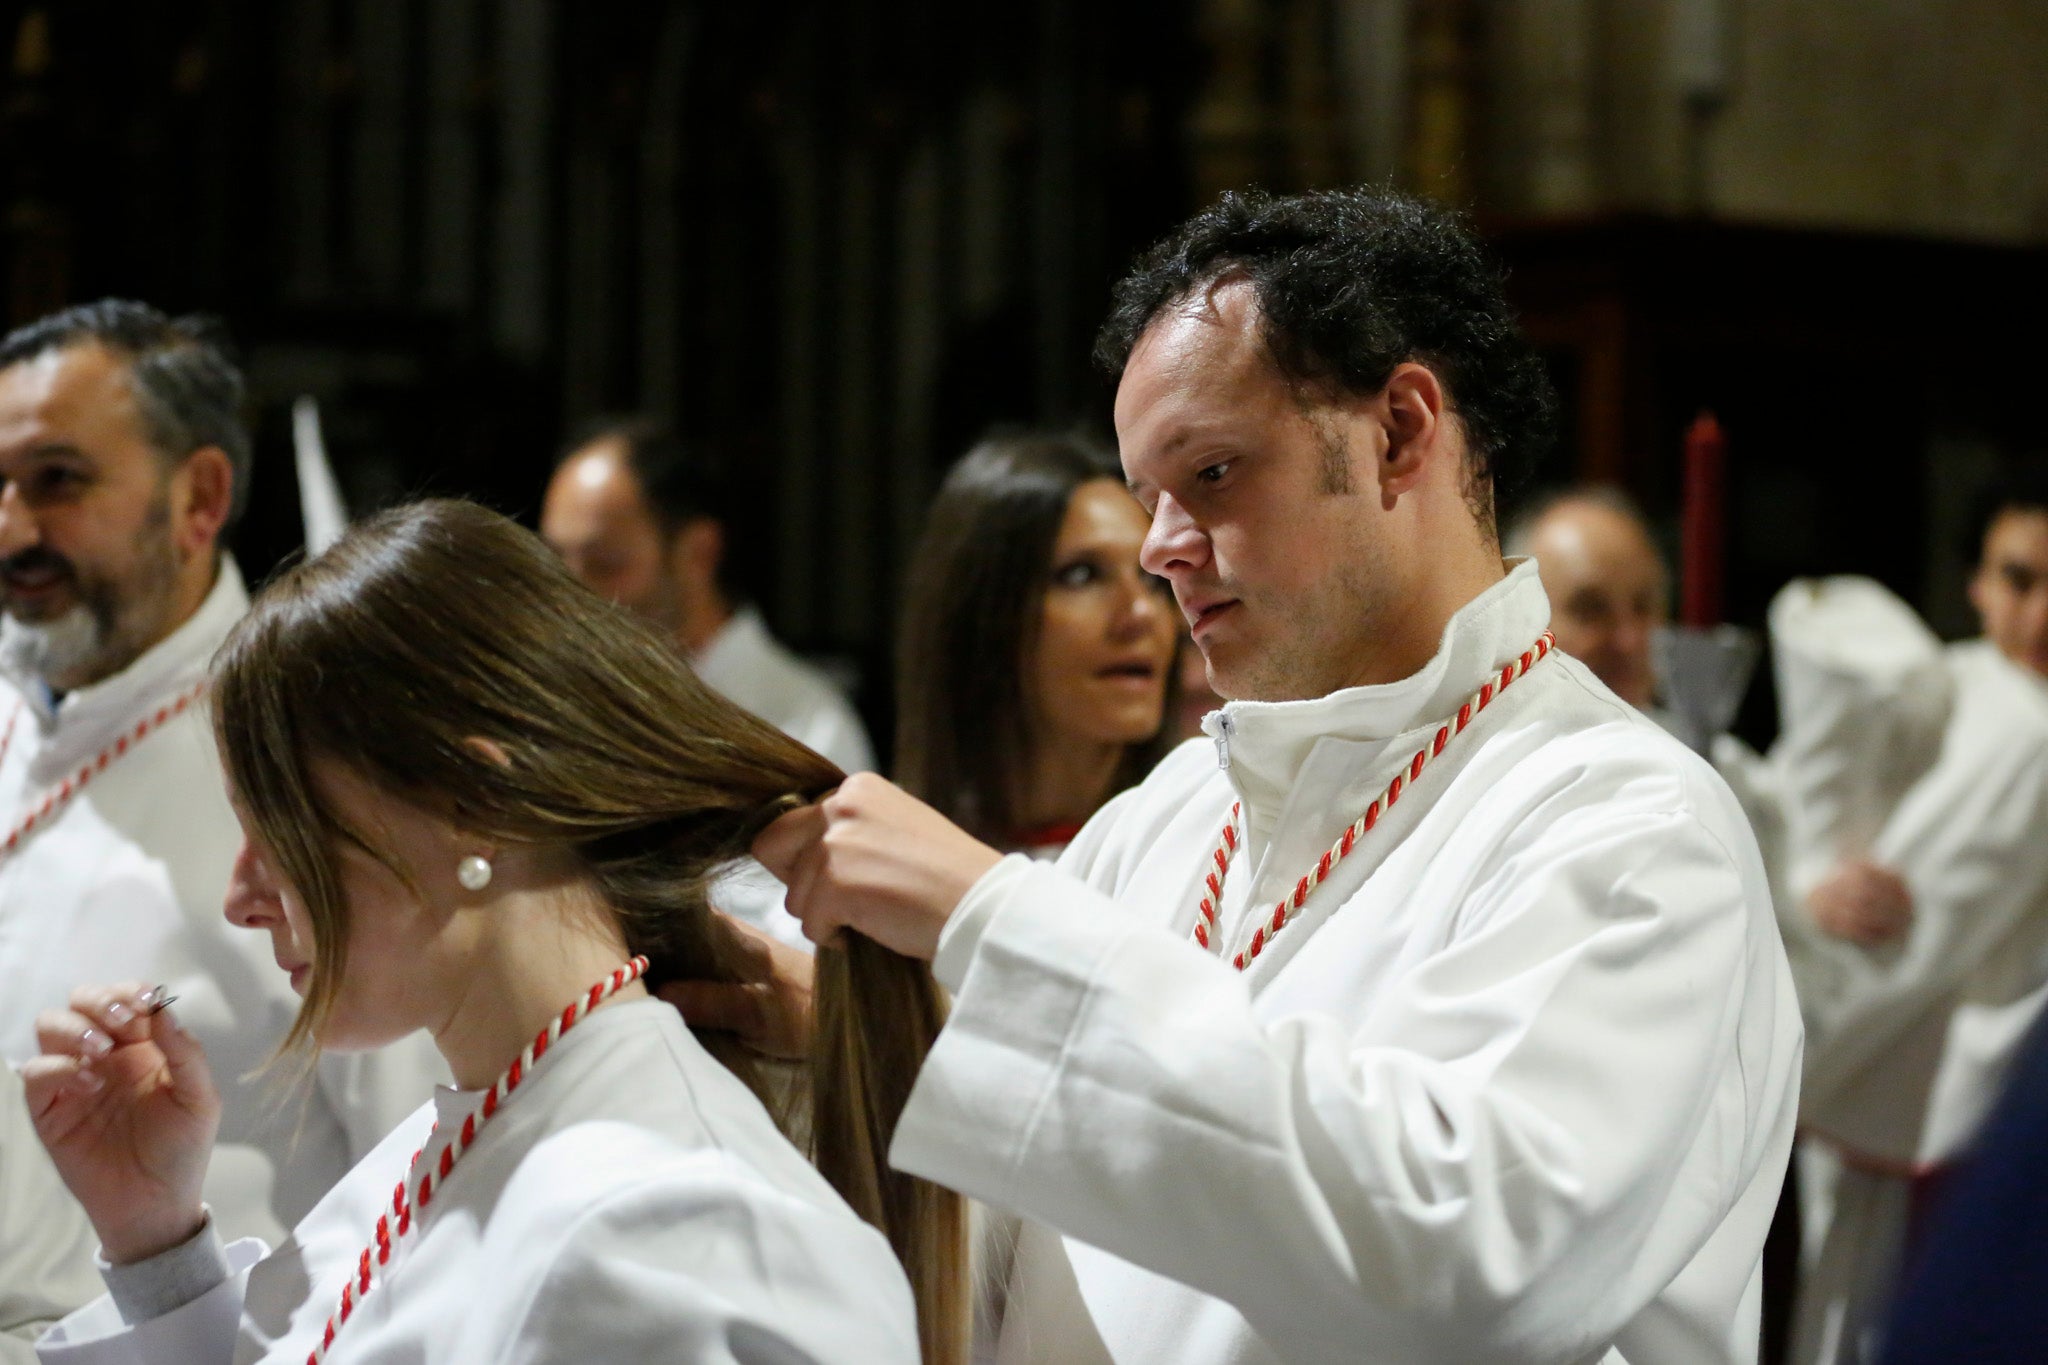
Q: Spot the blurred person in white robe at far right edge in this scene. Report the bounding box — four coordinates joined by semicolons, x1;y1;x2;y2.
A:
1772;473;2048;1365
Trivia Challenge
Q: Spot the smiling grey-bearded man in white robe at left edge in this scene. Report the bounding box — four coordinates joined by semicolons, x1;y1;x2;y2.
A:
0;301;442;1234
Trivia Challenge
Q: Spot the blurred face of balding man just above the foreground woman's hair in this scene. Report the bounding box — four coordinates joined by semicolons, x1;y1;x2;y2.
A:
541;440;682;632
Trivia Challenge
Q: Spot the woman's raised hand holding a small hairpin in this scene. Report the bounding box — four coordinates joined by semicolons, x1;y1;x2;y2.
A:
20;982;221;1265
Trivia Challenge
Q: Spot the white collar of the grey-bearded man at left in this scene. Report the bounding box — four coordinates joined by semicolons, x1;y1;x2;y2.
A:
12;555;250;772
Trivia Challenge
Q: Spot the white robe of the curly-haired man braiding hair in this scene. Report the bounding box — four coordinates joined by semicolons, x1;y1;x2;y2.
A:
891;561;1800;1365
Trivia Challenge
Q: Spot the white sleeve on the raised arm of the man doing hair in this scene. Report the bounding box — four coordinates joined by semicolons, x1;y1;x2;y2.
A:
891;810;1796;1365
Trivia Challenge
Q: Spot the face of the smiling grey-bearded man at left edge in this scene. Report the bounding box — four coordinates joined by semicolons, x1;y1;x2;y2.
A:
0;342;184;692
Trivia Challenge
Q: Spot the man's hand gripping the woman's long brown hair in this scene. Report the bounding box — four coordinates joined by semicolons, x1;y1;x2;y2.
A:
754;774;1001;962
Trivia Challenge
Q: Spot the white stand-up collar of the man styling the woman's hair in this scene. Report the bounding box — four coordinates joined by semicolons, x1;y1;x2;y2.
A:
1202;557;1550;855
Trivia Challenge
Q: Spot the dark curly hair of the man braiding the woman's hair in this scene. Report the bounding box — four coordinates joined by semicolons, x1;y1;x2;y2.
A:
1096;188;1556;530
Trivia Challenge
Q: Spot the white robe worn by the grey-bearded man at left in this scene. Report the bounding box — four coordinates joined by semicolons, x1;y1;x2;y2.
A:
0;559;446;1236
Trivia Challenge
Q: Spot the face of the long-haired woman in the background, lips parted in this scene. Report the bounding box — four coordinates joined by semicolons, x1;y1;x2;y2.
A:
1024;479;1178;745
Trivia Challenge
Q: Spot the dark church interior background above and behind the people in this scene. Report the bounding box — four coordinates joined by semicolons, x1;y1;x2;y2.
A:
0;0;2048;737
